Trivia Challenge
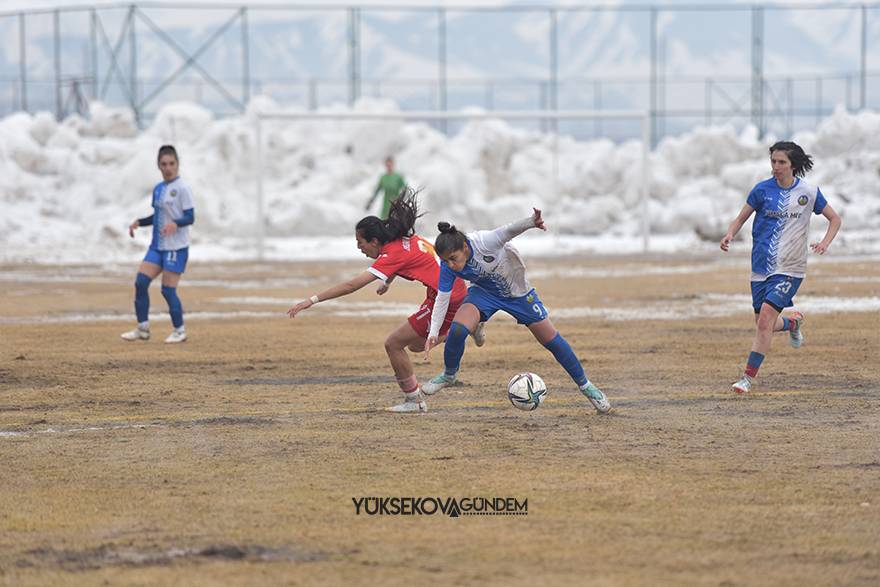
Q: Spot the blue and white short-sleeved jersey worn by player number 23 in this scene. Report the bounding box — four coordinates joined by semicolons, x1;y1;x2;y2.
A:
747;177;828;281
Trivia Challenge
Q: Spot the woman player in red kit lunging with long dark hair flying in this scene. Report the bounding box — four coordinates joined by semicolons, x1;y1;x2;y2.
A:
287;193;484;413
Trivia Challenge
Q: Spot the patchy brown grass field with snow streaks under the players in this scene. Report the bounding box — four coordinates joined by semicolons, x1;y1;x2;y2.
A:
0;253;880;586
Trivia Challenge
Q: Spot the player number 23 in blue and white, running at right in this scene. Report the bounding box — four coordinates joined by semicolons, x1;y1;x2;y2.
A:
721;141;840;393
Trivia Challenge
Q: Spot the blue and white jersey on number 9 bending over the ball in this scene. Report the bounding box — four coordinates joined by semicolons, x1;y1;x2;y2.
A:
440;227;532;298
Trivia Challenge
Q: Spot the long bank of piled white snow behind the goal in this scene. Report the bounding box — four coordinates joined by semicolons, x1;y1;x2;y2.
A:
0;97;880;263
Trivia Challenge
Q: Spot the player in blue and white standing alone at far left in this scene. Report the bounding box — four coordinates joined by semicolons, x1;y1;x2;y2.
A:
122;145;195;343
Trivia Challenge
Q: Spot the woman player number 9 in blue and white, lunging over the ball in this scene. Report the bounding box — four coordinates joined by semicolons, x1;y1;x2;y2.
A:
422;208;611;414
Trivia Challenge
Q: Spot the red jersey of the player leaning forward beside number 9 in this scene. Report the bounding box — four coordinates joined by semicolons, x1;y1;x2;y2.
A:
368;234;467;299
